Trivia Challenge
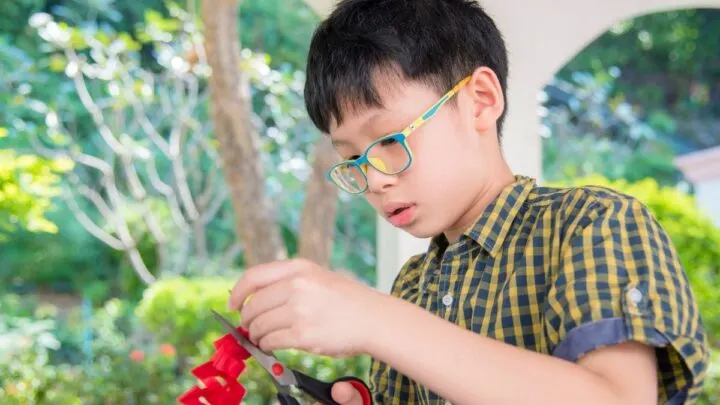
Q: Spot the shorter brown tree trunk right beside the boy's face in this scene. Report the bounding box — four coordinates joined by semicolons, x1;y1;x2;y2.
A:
298;135;338;266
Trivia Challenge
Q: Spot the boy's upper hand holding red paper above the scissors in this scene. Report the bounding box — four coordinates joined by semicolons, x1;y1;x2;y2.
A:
228;259;384;356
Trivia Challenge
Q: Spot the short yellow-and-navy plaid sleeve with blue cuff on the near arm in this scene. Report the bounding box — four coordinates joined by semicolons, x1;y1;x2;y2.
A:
544;197;709;405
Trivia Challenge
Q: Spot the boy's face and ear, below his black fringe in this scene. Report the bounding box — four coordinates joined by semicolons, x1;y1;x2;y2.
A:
330;69;504;239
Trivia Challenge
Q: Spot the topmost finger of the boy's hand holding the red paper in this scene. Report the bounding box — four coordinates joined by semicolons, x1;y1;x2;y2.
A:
228;260;307;310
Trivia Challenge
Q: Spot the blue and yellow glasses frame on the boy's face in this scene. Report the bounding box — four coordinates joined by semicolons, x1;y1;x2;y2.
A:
326;76;470;194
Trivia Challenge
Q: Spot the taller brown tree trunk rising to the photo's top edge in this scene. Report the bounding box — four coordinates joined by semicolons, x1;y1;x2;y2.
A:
202;0;286;266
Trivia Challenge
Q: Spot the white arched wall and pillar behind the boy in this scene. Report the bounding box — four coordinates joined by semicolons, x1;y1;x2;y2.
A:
300;0;720;291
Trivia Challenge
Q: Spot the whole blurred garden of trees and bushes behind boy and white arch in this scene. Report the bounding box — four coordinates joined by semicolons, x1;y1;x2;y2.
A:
0;0;720;405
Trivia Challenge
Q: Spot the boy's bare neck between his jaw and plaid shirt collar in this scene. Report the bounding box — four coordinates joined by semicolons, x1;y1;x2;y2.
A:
444;162;515;244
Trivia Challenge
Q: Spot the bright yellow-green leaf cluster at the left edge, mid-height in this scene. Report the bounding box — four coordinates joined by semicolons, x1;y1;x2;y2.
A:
0;148;72;241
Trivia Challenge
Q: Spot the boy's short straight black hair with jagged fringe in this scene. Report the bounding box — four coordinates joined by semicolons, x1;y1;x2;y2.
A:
305;0;508;134
